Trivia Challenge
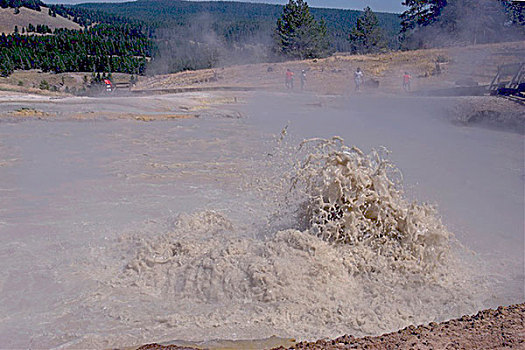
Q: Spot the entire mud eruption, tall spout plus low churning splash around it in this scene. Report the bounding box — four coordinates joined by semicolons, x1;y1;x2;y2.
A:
106;138;483;341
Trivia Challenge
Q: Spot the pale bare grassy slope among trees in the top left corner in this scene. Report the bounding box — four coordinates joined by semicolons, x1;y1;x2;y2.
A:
0;7;80;34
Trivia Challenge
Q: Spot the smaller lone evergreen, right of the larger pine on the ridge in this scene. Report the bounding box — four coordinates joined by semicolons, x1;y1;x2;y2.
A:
349;7;386;54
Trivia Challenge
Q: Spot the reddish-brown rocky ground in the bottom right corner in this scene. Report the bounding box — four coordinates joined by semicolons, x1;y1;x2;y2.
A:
137;303;525;350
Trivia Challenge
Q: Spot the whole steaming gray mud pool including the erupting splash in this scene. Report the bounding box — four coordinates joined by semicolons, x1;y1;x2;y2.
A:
0;94;525;348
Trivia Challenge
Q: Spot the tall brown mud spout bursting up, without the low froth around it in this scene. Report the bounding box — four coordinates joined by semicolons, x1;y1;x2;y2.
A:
295;137;450;273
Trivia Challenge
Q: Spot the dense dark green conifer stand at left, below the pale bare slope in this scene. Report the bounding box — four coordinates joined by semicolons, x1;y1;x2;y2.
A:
0;24;151;76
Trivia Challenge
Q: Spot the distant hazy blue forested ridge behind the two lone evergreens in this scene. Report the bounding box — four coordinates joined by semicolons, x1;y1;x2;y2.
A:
80;0;400;51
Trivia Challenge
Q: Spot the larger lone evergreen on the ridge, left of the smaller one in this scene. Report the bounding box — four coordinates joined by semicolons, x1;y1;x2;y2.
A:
276;0;331;59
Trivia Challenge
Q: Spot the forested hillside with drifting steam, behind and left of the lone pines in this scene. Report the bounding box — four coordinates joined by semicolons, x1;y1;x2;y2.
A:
0;0;400;76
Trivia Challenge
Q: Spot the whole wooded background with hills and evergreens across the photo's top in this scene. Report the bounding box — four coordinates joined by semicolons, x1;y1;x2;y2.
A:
0;0;524;80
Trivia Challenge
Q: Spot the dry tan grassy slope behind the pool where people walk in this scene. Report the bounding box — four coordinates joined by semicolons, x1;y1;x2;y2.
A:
136;41;525;94
